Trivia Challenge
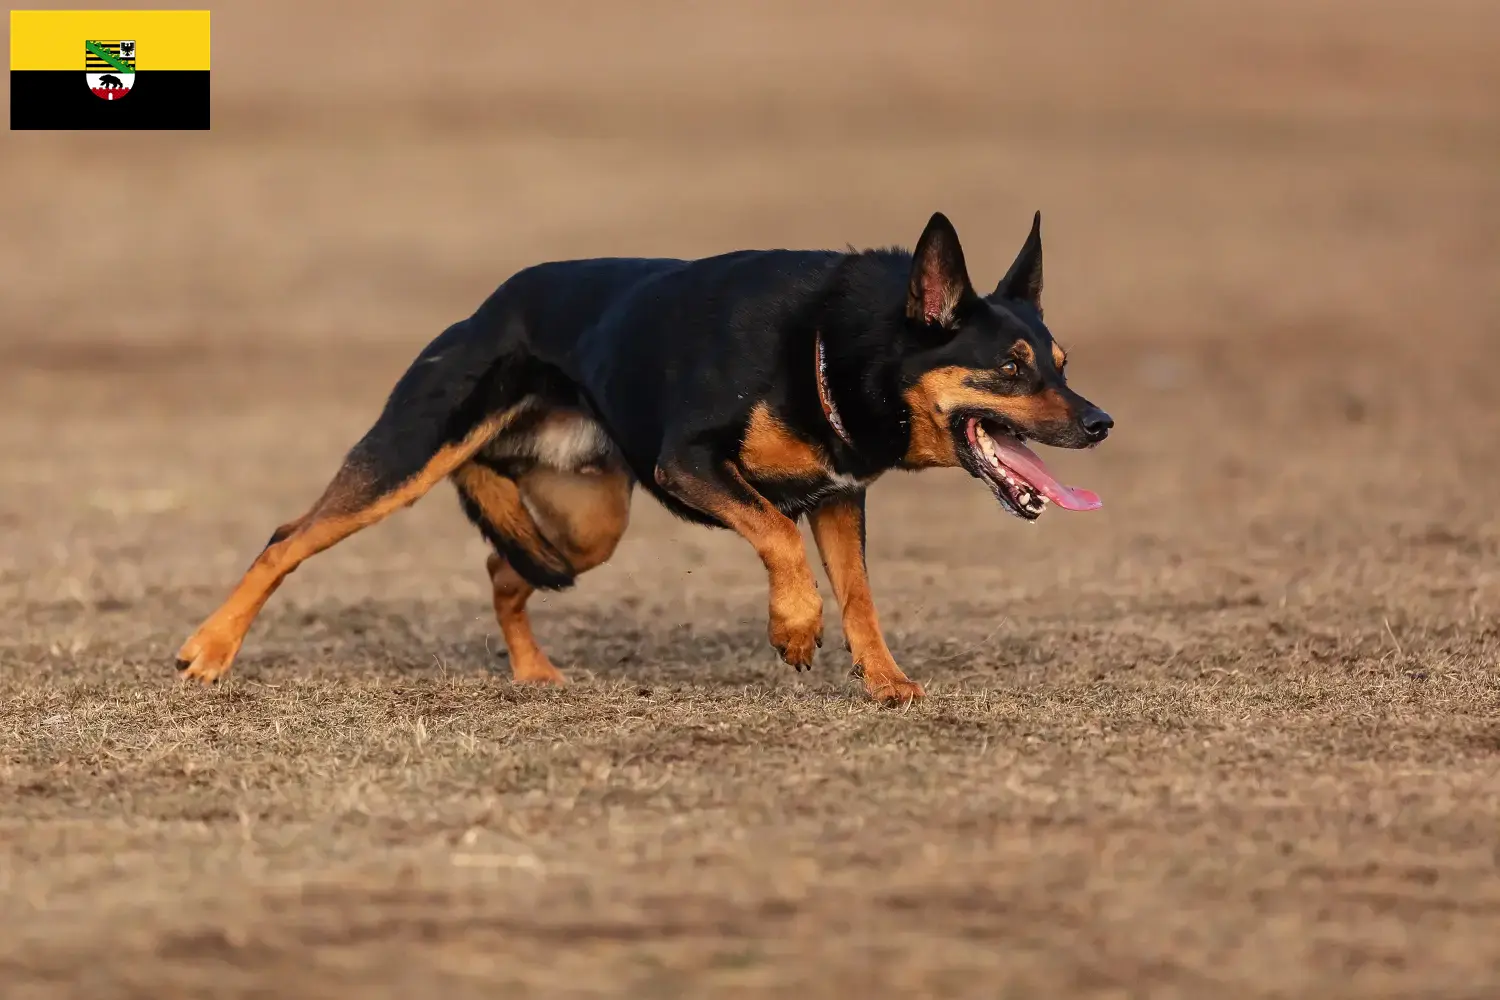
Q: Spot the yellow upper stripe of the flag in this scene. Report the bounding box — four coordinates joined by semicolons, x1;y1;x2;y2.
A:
11;10;209;73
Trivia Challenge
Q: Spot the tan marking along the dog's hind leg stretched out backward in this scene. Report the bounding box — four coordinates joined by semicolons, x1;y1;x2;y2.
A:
177;414;509;684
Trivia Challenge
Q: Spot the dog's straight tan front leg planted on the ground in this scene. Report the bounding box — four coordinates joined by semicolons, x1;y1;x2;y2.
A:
809;493;924;705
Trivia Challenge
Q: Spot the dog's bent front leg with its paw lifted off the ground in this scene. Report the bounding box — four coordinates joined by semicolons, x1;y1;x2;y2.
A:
656;453;824;670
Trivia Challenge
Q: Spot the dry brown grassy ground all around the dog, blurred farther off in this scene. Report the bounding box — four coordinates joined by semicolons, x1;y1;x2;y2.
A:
0;0;1500;1000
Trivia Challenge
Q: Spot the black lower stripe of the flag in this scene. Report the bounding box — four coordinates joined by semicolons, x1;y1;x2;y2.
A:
11;69;209;129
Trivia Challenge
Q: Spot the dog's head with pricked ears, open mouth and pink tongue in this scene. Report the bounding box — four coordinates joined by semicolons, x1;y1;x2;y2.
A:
902;213;1115;520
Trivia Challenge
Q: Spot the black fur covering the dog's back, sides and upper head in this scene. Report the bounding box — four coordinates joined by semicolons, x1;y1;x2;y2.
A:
351;214;1107;578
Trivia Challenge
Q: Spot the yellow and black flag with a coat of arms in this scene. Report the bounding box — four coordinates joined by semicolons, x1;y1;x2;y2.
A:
11;10;209;130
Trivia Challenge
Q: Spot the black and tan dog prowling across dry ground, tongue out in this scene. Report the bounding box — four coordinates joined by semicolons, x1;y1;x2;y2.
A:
177;214;1113;703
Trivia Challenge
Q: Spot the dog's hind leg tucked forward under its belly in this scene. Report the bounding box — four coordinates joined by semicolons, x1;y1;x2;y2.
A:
453;462;633;684
